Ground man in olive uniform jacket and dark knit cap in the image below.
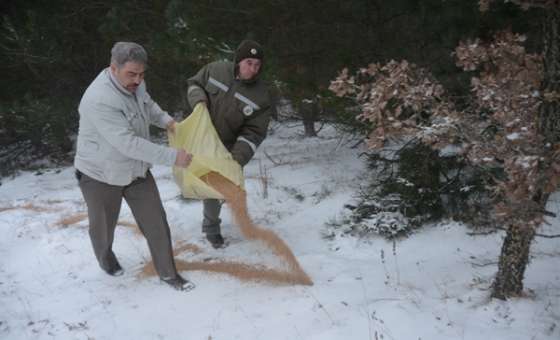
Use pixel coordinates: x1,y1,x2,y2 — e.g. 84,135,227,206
187,40,271,248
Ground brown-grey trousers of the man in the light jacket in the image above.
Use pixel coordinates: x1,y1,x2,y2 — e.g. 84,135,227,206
78,171,177,278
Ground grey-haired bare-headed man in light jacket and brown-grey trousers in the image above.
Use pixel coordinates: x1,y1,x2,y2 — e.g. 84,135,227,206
74,42,194,290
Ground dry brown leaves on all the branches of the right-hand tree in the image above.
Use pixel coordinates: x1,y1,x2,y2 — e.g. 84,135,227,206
330,31,548,226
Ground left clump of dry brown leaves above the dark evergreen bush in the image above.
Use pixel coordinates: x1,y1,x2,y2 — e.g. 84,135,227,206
329,60,453,149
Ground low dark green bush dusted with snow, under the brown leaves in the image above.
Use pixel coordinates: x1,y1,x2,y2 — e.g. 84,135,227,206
352,143,503,237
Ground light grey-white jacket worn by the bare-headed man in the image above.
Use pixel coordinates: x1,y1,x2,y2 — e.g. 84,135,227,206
74,68,177,186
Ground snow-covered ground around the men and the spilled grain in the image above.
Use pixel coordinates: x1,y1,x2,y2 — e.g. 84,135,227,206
0,123,560,340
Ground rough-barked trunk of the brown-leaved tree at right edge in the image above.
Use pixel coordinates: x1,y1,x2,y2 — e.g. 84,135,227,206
492,5,560,299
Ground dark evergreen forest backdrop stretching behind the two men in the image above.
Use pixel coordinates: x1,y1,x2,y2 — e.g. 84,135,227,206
0,0,536,175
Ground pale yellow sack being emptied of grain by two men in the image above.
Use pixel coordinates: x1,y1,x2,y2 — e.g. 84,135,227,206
169,104,244,199
